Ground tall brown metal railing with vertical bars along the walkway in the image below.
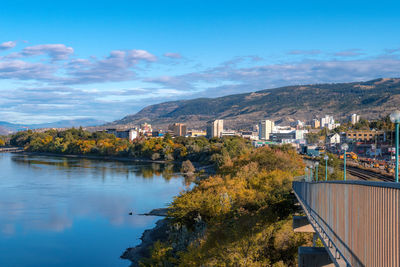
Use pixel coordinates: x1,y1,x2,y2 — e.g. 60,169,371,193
293,181,400,267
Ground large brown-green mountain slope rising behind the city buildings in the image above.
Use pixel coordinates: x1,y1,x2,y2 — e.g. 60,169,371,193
112,78,400,129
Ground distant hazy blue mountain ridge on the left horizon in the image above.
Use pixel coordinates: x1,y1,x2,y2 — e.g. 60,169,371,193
0,118,104,135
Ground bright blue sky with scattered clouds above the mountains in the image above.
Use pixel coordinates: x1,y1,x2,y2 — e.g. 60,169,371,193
0,0,400,124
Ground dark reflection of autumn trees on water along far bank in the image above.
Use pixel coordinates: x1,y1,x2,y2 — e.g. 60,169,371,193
11,155,184,182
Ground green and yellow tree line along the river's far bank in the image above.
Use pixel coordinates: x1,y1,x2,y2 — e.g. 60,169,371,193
9,128,250,164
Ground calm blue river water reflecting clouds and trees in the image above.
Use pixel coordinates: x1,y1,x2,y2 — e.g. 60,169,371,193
0,153,186,267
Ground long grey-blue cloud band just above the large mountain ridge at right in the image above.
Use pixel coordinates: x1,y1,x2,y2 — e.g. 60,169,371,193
146,56,400,96
